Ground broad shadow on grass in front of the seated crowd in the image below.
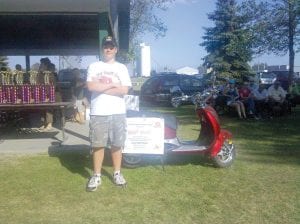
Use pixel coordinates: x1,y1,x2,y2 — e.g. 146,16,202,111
222,107,300,164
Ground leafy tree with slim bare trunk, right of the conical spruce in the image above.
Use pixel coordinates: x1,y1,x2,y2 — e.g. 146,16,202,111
243,0,300,85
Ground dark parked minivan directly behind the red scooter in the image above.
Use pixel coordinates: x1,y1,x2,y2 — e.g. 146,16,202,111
140,73,204,105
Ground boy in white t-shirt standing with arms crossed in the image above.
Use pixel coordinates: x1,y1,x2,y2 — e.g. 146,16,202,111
87,36,131,191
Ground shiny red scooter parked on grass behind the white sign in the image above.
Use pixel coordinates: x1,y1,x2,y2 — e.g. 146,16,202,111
123,89,236,167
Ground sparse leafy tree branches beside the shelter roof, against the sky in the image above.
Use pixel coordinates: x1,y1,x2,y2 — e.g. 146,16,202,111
120,0,174,62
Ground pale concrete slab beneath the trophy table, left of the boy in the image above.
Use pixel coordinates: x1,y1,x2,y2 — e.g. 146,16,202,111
0,121,90,154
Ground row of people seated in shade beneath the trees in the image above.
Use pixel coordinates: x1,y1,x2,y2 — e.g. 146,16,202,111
215,78,300,120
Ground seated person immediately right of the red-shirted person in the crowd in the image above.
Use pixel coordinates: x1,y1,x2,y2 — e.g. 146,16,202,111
253,83,268,118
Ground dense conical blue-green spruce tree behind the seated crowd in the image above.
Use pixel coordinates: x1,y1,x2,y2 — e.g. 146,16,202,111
200,0,252,79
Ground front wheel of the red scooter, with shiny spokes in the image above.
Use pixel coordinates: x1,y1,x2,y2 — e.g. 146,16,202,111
212,141,236,168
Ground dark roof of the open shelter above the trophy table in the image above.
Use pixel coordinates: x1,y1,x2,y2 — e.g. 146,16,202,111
0,0,130,67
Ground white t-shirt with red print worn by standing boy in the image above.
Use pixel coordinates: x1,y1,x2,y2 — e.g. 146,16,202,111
87,61,131,115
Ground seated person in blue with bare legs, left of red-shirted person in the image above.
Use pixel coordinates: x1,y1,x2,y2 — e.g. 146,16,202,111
223,80,247,119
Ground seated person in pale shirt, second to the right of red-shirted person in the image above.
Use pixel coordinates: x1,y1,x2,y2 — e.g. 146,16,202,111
268,80,287,115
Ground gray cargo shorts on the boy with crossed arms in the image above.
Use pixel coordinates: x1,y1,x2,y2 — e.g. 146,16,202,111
89,114,126,148
